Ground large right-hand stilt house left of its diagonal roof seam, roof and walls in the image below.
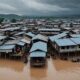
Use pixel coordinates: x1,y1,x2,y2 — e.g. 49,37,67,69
54,38,77,58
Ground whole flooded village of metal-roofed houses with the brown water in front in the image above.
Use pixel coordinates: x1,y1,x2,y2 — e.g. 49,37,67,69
0,18,80,80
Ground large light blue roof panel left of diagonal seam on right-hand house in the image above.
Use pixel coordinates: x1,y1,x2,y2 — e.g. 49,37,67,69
55,38,76,46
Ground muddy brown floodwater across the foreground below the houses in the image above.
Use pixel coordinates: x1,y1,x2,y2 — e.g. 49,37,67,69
0,59,80,80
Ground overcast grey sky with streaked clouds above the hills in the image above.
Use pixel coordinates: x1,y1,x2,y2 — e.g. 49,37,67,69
0,0,80,15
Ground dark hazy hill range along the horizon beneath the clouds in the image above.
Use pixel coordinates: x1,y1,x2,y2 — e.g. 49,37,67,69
0,14,80,19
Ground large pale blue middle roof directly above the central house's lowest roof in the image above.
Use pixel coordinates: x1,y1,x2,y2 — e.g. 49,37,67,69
30,41,47,52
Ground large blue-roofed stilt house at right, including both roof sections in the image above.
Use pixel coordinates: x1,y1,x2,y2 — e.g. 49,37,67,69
54,38,80,59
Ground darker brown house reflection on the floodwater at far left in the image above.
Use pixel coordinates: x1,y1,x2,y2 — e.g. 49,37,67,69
0,59,25,72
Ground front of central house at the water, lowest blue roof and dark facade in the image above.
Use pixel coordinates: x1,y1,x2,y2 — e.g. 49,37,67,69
30,51,46,66
